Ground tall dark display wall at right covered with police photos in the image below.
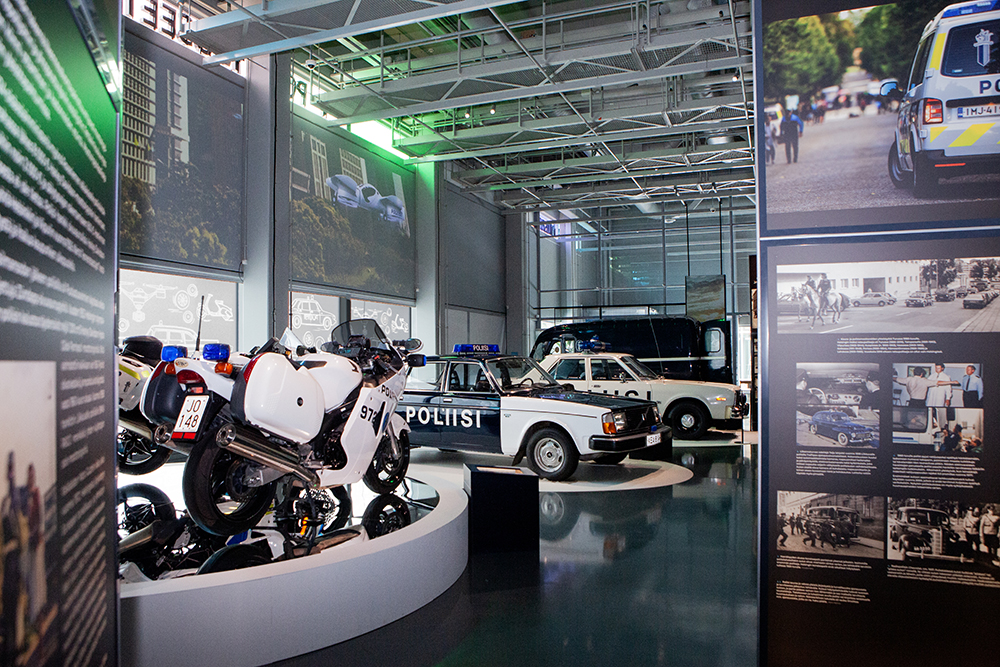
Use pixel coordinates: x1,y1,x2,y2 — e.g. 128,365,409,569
755,0,1000,667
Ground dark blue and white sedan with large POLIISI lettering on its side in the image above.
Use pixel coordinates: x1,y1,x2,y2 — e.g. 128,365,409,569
396,345,670,481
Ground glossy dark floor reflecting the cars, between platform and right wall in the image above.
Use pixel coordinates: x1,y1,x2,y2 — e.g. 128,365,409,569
275,445,757,667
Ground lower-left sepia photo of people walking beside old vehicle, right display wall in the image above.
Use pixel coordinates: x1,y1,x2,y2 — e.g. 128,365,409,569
774,491,885,558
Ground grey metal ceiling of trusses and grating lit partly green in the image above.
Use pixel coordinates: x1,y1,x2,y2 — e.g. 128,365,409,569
180,0,755,213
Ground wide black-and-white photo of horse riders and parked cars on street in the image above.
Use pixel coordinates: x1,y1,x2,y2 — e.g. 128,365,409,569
775,257,1000,334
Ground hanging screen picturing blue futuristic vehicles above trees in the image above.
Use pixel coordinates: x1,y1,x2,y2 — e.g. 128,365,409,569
290,110,416,299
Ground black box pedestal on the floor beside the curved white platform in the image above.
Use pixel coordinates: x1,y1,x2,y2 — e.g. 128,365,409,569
465,464,538,556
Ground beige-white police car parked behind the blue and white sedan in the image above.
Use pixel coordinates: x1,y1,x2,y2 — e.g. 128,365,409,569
541,352,746,440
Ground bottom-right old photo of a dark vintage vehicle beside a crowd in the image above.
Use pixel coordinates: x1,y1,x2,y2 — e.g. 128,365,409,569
887,498,1000,570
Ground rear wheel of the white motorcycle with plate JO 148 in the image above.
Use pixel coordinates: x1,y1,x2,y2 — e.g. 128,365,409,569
182,428,274,535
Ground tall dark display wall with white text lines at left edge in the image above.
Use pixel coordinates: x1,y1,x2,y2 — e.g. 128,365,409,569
0,1,118,665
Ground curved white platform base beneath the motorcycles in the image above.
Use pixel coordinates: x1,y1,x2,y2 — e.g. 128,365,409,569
121,474,468,667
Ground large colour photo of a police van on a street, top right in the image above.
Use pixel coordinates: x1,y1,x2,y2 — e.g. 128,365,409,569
758,0,1000,229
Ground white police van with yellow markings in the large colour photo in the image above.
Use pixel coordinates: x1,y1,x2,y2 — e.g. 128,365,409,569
880,0,1000,196
